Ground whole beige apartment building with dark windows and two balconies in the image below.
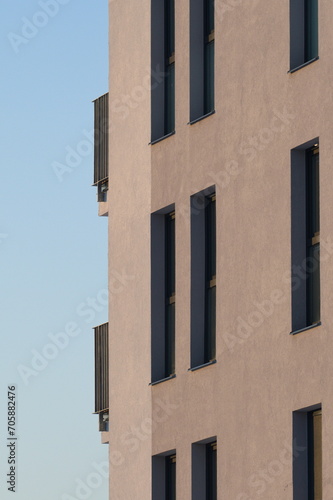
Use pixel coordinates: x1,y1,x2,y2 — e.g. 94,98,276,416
94,0,333,500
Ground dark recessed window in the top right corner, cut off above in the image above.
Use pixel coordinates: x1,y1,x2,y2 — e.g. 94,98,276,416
290,0,319,70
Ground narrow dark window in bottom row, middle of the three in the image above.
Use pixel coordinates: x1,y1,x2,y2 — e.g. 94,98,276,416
192,437,217,500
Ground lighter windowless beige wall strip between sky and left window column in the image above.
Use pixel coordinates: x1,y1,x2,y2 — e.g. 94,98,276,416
108,0,151,500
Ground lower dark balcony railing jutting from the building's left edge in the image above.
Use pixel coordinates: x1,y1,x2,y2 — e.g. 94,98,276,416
94,323,109,431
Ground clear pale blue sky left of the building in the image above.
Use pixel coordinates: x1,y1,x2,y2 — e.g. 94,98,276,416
0,0,108,500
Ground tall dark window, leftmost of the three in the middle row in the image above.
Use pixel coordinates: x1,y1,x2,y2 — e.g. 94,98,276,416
151,206,176,383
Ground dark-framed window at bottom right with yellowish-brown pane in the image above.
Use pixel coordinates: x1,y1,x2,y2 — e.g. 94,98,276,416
293,405,322,500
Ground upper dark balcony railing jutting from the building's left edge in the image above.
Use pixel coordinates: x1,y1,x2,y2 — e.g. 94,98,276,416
94,93,109,201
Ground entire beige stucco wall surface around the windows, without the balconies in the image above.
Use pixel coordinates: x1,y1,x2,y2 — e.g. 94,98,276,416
108,0,333,500
